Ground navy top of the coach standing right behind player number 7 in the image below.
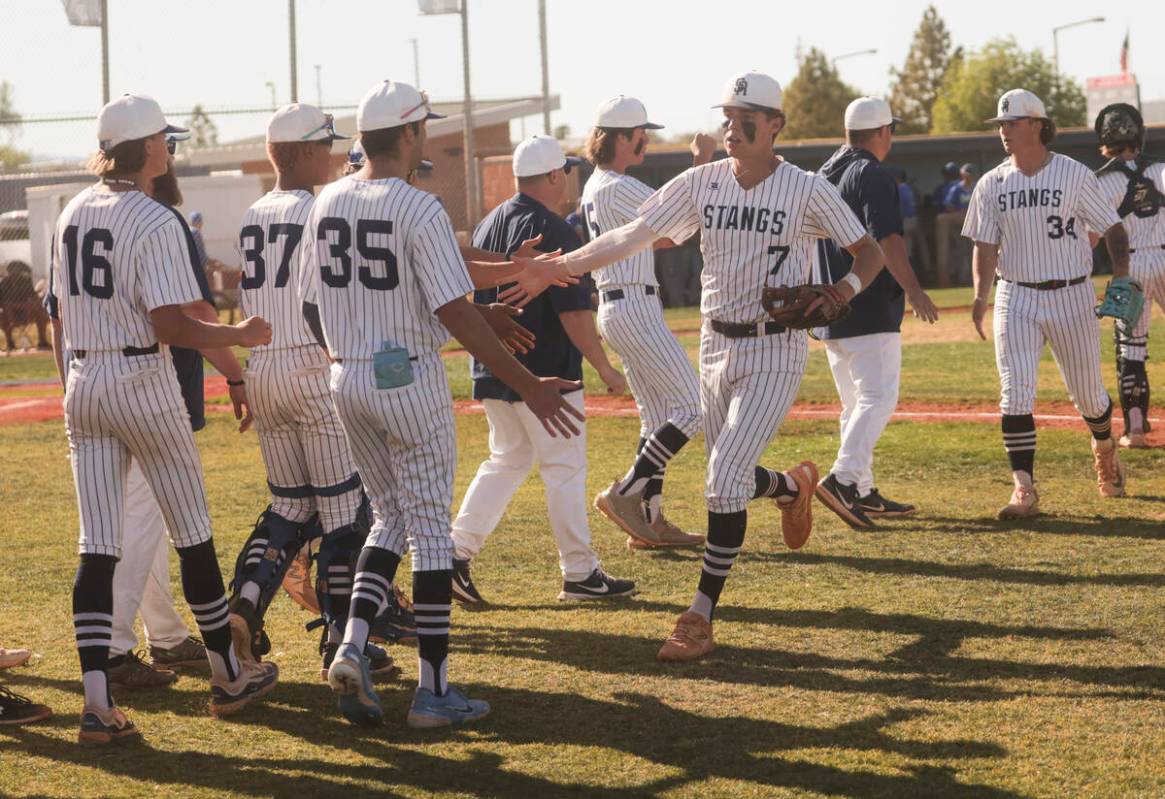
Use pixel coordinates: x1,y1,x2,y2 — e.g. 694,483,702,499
818,144,906,339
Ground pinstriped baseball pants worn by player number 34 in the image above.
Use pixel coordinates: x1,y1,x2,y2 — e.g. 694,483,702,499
991,281,1110,417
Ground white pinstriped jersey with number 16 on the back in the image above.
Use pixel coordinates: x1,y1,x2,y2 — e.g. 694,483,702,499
50,185,203,351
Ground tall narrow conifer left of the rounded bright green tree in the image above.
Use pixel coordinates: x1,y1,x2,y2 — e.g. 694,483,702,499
890,6,962,133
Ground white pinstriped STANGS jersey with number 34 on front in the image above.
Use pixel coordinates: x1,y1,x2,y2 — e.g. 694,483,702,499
962,153,1121,283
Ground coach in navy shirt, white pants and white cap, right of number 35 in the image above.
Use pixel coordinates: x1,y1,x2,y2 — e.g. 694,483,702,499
453,136,635,603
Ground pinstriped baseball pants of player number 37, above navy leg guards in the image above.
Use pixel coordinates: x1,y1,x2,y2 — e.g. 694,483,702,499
247,345,361,532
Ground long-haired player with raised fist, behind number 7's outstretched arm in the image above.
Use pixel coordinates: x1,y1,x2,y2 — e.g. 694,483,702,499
579,94,704,546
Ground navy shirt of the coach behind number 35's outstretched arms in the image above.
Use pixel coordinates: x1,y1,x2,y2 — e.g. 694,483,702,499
469,192,591,402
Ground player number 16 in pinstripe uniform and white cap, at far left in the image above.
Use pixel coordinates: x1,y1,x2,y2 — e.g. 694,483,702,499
50,94,278,745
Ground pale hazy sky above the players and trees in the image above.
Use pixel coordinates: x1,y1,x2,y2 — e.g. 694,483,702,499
0,0,1165,154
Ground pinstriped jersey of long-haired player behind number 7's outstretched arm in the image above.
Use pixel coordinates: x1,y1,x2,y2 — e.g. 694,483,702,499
579,167,659,291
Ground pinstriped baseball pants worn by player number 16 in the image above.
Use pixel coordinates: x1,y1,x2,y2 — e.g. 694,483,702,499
64,347,211,558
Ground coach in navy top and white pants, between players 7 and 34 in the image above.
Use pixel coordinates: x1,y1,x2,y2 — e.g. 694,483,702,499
818,97,938,528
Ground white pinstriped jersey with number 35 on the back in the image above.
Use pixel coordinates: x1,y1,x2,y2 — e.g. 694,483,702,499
302,176,473,359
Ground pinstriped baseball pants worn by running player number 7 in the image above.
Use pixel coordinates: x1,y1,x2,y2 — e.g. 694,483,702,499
700,325,809,514
